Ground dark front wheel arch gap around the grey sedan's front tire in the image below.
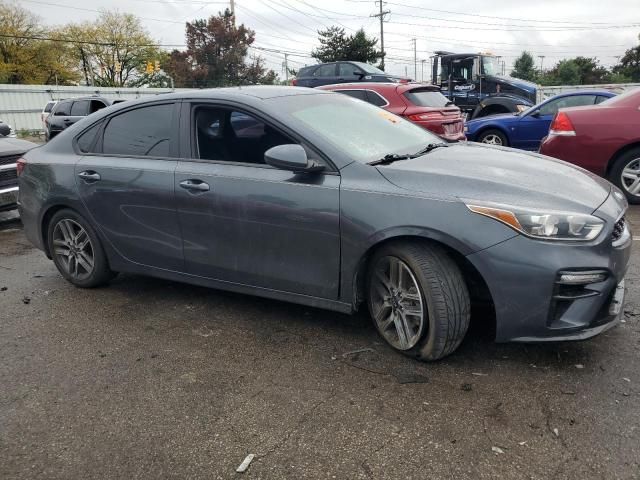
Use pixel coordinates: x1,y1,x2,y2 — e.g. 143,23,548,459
352,233,496,338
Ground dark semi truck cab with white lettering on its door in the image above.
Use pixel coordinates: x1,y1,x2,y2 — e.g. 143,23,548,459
431,52,537,118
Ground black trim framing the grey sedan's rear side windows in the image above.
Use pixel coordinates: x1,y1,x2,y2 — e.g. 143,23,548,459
72,99,182,162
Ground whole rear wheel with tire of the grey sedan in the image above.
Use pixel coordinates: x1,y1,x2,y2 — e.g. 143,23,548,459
47,209,115,288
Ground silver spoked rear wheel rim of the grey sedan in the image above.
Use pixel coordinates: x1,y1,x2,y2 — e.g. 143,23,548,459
53,218,94,280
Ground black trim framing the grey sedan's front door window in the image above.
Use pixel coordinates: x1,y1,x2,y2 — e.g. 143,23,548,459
180,98,339,175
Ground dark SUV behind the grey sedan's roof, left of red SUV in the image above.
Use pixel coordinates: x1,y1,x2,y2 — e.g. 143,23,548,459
292,62,411,87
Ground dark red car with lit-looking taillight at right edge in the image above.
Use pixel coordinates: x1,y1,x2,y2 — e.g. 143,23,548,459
540,88,640,203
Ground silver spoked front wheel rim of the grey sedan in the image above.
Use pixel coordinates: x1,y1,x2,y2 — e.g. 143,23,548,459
370,257,425,350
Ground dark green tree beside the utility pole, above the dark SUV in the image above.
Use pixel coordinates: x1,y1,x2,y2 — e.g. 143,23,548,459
311,26,382,63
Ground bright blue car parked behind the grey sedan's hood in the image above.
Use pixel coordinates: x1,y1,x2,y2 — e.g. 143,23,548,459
464,90,615,151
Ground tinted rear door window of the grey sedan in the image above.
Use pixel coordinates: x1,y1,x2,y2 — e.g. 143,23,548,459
102,103,173,157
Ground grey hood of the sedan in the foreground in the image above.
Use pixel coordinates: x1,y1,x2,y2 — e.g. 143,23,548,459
378,143,611,213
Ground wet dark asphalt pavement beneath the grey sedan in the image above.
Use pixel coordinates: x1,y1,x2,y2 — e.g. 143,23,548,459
0,208,640,480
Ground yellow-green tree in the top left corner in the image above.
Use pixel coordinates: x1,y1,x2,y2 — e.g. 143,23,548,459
0,2,76,84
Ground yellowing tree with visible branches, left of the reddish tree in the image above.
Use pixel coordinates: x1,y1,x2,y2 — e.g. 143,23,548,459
59,12,164,87
